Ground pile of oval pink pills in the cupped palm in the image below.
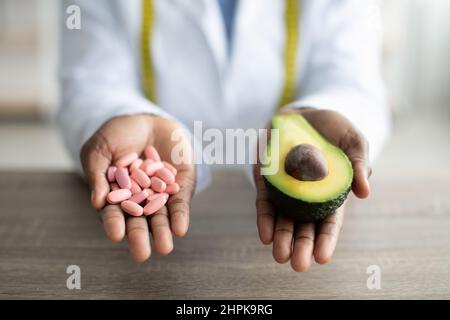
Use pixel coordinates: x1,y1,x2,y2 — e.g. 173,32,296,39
106,146,180,216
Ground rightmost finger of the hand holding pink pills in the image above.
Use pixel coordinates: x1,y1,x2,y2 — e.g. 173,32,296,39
167,165,195,237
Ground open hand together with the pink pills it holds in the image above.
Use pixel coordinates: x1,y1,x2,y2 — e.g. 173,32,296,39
81,115,195,262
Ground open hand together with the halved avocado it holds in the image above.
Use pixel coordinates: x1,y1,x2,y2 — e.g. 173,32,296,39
254,108,371,271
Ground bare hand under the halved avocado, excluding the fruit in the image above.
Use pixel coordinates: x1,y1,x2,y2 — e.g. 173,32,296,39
254,108,371,272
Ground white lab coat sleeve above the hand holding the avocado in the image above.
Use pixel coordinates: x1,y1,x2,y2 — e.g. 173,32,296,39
290,0,389,160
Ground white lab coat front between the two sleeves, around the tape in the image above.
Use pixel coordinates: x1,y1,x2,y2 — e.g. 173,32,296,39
117,0,311,128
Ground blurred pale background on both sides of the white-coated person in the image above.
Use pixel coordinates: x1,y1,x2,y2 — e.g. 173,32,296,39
0,0,450,177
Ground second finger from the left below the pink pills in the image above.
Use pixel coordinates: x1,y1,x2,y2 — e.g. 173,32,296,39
126,216,151,262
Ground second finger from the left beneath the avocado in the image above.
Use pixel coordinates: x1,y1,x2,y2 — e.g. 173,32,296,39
272,216,294,263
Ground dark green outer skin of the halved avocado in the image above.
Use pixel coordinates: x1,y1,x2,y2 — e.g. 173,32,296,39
264,177,351,222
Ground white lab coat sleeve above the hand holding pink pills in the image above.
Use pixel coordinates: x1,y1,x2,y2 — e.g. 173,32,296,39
58,0,208,190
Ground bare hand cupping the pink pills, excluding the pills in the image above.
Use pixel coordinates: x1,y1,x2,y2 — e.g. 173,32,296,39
81,115,196,262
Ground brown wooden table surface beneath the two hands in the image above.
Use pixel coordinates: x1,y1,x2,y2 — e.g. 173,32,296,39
0,172,450,299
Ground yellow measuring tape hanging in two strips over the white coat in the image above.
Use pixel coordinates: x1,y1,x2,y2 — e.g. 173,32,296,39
141,0,300,108
